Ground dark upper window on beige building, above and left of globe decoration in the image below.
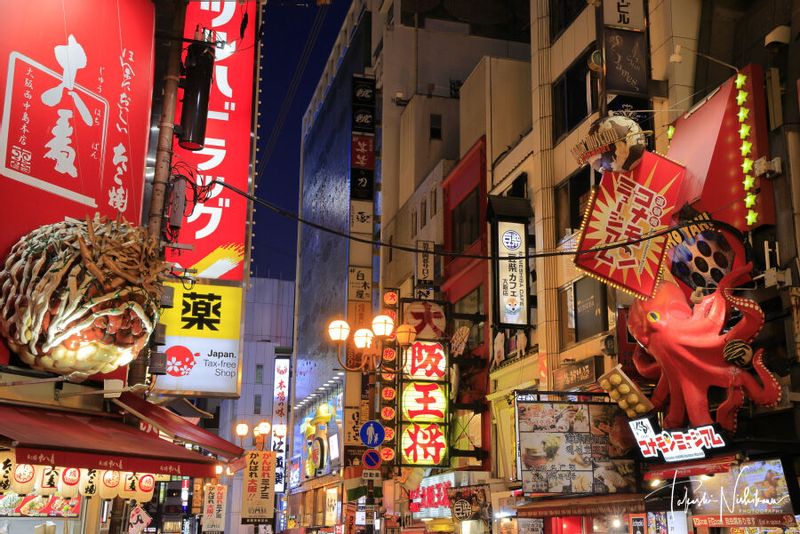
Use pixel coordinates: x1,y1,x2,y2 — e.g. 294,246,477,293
553,48,597,144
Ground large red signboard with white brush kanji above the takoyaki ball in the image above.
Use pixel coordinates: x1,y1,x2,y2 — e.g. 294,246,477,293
0,0,155,276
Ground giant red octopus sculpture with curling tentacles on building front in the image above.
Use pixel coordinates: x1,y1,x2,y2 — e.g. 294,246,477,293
628,264,781,432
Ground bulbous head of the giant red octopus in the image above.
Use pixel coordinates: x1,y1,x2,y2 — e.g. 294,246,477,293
628,282,692,347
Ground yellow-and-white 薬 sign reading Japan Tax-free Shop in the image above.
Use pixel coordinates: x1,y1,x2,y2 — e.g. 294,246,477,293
155,283,241,398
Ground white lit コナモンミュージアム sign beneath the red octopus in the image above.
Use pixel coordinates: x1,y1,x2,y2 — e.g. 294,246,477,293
628,418,725,462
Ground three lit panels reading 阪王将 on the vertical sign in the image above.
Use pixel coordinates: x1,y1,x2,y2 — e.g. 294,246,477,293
398,341,449,466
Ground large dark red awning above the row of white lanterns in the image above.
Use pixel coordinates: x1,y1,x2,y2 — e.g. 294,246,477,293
0,405,216,477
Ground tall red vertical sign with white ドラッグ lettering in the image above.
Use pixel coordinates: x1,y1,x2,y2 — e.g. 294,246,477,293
167,0,258,281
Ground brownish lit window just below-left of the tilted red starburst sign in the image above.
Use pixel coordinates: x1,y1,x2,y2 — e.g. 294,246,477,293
558,276,608,349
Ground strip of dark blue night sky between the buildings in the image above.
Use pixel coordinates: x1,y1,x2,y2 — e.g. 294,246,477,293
252,0,350,280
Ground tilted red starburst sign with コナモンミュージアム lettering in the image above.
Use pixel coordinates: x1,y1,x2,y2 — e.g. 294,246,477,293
575,152,685,298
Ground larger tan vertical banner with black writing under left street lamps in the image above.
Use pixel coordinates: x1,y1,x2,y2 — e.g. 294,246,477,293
242,450,275,525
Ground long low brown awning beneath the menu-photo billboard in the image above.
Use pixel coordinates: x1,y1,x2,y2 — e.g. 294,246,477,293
517,493,645,517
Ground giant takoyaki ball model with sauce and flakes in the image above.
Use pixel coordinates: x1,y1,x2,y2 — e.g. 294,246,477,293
0,216,165,375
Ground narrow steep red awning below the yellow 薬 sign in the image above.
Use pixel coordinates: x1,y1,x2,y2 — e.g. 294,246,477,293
114,393,244,459
